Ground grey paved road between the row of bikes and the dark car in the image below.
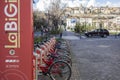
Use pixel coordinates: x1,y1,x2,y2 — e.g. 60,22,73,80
63,32,120,80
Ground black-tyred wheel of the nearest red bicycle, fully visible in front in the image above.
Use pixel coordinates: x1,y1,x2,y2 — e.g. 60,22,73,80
49,61,71,80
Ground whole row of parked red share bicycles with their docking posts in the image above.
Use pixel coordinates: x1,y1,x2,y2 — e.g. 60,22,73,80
33,37,72,80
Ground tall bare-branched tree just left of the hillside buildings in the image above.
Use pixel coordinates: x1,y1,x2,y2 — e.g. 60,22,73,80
46,0,66,30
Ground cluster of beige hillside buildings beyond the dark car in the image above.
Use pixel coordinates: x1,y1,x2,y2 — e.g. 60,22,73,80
64,5,120,30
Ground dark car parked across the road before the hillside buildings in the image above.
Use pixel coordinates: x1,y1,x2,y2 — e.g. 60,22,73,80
85,29,109,37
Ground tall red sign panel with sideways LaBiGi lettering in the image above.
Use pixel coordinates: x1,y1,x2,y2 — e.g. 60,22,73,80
0,0,33,80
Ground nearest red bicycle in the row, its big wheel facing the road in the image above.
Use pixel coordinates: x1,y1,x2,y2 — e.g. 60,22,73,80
37,49,72,80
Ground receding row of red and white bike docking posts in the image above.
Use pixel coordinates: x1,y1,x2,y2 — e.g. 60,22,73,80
33,37,56,80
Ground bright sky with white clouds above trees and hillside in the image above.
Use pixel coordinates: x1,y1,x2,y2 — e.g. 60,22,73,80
33,0,120,11
